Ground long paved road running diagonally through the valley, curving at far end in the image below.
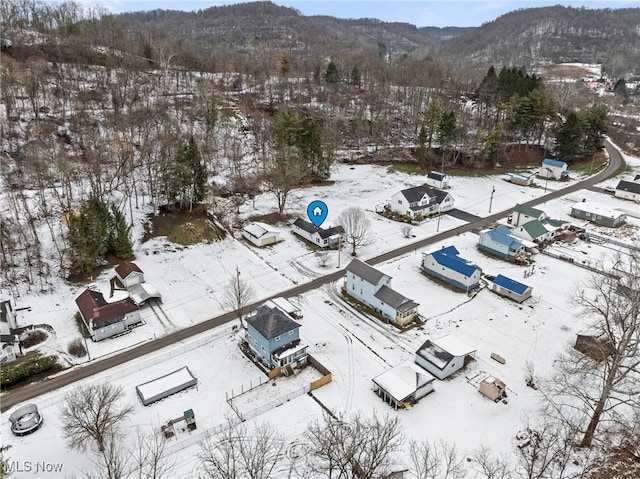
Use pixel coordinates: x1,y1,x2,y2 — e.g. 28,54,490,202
0,140,624,412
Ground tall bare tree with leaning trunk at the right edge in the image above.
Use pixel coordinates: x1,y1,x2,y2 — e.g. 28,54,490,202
545,249,640,447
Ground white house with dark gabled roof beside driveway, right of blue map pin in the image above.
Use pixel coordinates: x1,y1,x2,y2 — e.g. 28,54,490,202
389,185,453,219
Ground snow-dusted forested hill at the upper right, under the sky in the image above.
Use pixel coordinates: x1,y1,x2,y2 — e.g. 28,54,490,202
439,5,640,77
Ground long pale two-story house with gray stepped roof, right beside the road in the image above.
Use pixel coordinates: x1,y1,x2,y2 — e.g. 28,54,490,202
345,259,418,327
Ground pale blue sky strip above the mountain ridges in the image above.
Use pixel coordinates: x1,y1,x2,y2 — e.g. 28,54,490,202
75,0,640,27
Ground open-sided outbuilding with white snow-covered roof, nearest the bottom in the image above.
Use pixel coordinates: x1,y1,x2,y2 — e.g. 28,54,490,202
372,361,435,409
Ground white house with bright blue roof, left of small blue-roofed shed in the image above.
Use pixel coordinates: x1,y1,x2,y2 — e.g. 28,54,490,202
422,246,482,291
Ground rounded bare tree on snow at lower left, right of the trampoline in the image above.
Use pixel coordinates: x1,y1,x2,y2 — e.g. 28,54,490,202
60,383,133,451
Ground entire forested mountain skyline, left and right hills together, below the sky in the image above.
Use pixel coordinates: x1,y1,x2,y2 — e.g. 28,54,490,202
119,2,640,76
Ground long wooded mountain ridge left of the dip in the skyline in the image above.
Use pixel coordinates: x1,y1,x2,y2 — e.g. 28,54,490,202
120,2,467,58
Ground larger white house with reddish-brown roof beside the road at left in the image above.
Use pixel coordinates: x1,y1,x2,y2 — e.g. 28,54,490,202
76,289,142,341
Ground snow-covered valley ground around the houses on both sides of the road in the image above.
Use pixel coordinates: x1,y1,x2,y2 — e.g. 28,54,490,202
0,143,640,478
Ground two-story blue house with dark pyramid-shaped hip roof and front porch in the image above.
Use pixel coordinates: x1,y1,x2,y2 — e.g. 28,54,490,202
246,306,307,369
